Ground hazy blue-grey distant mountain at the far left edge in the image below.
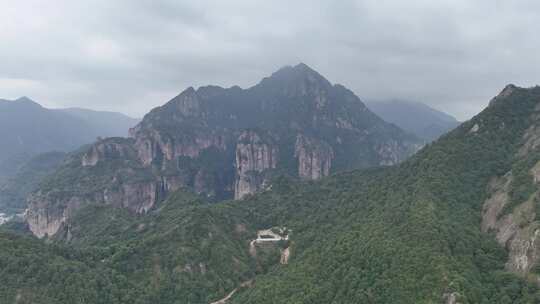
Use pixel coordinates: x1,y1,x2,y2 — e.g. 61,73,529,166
0,97,138,180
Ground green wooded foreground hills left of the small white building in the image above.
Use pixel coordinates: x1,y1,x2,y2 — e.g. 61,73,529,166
0,191,279,304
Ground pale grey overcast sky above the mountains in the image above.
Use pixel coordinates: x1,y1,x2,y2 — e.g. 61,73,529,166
0,0,540,119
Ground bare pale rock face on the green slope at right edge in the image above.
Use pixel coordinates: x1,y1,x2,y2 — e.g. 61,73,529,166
482,98,540,283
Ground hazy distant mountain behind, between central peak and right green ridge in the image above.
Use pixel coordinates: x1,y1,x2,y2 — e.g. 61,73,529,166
367,100,459,142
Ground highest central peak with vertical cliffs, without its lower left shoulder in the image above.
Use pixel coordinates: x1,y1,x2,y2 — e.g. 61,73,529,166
131,64,417,198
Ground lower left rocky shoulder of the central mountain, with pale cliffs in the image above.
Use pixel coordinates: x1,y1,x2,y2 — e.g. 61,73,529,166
26,138,175,237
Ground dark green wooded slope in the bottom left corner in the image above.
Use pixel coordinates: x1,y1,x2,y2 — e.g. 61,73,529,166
0,231,140,304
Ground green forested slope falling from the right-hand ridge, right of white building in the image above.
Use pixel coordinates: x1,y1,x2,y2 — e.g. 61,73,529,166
233,86,540,303
